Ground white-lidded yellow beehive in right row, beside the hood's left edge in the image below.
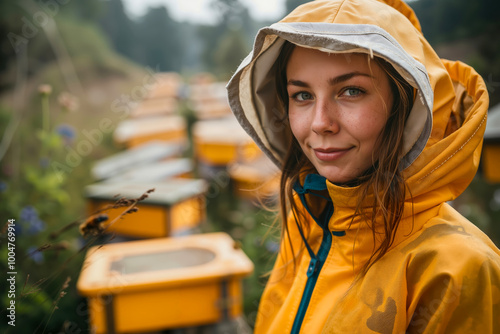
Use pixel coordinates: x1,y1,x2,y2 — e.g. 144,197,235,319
193,117,262,166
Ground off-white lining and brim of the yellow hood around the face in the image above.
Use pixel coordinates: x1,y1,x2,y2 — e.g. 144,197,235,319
227,23,433,168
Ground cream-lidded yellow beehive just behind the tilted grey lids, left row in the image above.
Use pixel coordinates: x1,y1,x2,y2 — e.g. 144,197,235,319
114,115,187,148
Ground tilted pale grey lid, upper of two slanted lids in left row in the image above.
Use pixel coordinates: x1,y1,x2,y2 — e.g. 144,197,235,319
92,141,184,180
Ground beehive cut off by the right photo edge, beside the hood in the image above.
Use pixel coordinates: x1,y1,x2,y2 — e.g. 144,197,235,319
481,105,500,183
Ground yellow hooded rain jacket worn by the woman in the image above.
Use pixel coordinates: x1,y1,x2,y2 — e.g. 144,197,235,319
227,0,500,334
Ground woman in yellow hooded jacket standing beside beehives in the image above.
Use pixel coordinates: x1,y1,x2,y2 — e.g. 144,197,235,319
228,0,500,333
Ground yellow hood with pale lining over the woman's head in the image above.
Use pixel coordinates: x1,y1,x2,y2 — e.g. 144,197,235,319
227,0,488,202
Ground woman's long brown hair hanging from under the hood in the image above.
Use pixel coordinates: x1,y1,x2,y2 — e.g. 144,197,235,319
275,41,414,275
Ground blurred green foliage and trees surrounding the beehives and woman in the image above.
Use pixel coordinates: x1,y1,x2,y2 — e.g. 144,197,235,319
0,0,500,333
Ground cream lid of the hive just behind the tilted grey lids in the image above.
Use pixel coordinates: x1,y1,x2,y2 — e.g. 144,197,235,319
114,115,186,142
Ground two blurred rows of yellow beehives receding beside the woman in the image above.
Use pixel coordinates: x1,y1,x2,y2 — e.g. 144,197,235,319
74,74,284,333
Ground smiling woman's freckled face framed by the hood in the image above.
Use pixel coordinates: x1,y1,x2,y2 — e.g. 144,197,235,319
286,46,393,184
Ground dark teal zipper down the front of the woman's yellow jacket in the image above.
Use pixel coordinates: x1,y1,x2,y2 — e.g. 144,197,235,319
291,228,332,334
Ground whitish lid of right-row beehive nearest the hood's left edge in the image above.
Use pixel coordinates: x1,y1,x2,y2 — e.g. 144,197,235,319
193,116,252,144
